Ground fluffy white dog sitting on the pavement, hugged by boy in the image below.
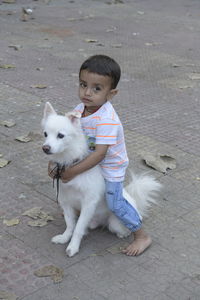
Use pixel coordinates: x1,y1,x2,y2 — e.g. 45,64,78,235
42,102,161,257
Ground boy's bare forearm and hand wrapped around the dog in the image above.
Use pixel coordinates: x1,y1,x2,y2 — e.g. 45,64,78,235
61,144,109,182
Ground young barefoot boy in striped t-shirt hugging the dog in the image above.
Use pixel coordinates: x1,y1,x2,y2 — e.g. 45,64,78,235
49,55,151,256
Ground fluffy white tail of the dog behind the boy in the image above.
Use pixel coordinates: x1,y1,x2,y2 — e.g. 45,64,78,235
124,172,162,217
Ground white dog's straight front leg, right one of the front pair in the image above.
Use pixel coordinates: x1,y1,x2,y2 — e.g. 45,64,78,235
66,205,96,257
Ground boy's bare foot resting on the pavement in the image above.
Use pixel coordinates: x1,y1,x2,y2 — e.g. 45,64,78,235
122,229,152,256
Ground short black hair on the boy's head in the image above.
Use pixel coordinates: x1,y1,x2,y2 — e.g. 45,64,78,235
79,54,121,89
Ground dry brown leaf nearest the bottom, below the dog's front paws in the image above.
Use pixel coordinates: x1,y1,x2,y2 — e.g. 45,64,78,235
34,265,64,283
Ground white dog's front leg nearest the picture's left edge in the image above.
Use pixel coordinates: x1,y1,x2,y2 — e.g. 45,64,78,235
51,206,76,244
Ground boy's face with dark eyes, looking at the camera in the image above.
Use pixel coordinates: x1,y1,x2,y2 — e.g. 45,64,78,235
79,70,117,109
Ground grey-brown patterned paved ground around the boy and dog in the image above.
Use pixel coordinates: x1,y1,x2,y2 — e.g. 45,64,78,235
0,0,200,300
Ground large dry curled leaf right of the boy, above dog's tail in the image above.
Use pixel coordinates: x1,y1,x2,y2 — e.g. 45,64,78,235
142,153,176,173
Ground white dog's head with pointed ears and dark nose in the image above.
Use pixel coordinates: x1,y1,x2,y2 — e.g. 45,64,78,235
42,102,81,154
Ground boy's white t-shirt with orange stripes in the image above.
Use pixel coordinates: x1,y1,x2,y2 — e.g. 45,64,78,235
74,101,128,181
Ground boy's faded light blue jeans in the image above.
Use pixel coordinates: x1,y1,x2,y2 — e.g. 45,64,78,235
105,180,142,232
